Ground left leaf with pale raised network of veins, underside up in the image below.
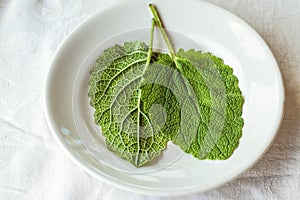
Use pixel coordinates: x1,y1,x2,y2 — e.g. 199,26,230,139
88,42,177,166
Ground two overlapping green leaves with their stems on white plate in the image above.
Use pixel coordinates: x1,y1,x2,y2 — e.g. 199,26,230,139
89,5,244,167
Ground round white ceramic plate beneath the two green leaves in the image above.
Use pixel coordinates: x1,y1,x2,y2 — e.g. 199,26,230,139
45,0,284,196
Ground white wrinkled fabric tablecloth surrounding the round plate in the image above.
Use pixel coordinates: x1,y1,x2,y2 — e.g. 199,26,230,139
0,0,300,200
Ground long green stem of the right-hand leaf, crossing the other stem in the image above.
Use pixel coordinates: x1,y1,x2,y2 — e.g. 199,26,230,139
149,4,175,61
